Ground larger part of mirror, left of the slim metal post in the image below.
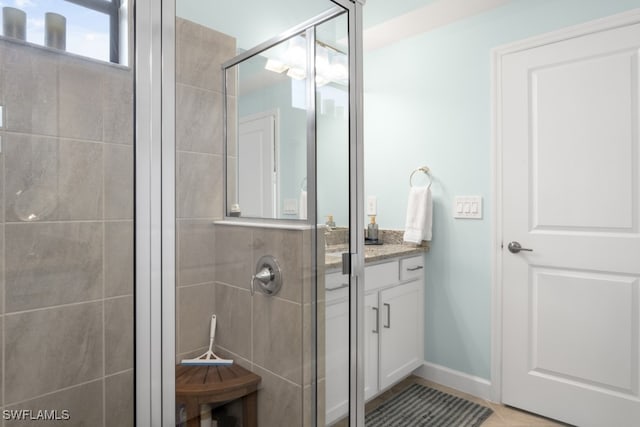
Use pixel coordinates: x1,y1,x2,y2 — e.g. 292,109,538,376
226,35,307,219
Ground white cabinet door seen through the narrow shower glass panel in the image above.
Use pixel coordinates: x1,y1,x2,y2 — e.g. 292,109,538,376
325,300,349,424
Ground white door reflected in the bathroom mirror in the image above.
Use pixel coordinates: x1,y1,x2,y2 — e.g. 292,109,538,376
238,111,278,218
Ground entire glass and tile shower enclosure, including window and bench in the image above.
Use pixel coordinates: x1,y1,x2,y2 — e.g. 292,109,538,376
0,0,363,426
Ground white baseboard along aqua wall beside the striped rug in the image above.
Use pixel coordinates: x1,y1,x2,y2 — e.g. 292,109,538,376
413,362,493,400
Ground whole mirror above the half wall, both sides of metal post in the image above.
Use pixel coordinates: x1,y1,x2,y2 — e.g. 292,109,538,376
225,11,348,221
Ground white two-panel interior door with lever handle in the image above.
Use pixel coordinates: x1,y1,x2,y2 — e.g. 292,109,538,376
498,17,640,427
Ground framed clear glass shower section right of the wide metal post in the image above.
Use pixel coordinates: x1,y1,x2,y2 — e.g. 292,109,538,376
168,0,364,426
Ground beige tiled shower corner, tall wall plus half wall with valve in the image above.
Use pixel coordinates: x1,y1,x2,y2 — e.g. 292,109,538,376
176,18,324,427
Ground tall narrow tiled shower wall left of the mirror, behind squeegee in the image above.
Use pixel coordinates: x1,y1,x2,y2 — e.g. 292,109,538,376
176,18,235,360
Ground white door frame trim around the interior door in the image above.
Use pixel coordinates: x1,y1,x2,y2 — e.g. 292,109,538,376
491,9,640,406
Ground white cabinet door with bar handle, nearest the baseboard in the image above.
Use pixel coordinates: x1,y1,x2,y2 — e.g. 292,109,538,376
380,280,424,390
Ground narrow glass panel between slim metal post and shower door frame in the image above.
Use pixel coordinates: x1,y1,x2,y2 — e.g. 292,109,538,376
315,13,352,425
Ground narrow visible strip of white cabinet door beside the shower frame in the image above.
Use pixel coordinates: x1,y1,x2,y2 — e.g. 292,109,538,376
364,292,380,400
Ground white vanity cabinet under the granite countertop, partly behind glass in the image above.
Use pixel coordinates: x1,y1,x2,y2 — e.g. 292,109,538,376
325,254,424,424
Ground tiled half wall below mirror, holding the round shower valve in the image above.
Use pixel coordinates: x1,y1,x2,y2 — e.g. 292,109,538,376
214,224,324,427
